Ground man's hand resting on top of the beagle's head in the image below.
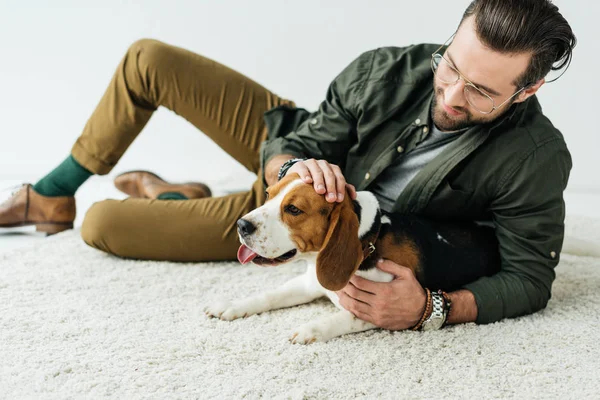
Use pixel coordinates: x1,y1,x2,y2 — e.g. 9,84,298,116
288,158,356,203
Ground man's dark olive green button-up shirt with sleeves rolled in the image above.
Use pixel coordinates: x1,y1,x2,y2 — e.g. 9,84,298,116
261,44,571,323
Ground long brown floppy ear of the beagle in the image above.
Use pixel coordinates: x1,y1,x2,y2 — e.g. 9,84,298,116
317,195,363,291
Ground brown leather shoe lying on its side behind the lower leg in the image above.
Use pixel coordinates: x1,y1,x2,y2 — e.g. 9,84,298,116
115,171,212,199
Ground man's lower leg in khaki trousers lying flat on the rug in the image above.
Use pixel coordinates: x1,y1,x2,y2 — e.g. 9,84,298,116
81,178,265,262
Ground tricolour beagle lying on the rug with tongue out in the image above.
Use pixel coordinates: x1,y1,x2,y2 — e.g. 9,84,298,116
205,174,500,344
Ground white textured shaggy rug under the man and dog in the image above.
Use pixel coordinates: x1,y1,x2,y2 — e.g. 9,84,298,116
0,219,600,399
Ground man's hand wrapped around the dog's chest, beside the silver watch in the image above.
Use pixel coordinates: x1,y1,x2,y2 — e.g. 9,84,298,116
336,260,427,330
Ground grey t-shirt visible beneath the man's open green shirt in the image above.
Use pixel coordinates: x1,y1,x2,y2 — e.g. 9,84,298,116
369,124,466,212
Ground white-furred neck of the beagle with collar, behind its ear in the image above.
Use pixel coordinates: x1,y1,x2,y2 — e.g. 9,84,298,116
353,192,381,263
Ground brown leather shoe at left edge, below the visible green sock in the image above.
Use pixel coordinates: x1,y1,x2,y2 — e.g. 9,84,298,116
0,184,75,235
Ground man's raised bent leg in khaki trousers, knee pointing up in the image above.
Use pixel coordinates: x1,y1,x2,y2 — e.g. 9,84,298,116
72,39,293,175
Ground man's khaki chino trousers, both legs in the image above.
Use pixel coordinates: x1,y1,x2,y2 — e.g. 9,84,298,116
72,39,294,261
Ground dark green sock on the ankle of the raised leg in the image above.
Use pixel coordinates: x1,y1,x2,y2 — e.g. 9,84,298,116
33,155,94,197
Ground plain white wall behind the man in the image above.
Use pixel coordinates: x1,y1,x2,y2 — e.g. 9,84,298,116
0,0,600,192
